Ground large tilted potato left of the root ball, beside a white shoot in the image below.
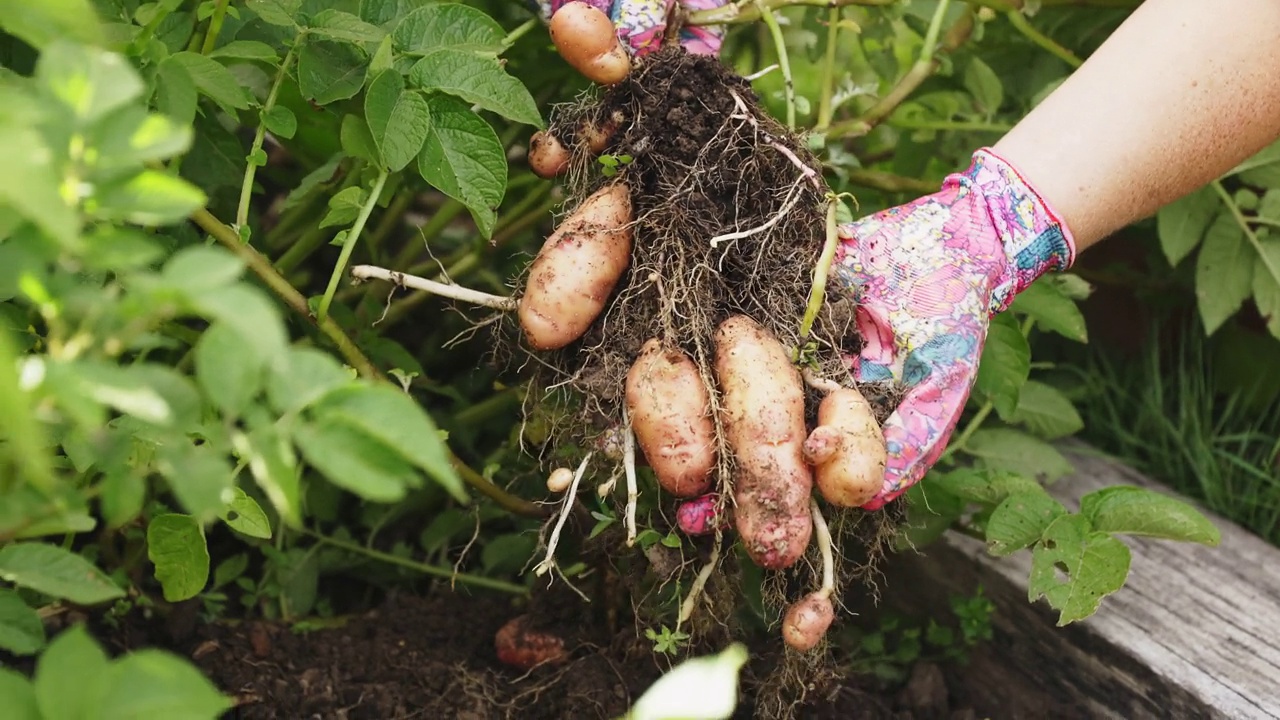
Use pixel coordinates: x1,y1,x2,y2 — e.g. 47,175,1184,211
518,183,631,350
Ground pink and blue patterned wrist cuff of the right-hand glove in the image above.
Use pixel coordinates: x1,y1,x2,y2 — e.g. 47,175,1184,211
947,147,1075,315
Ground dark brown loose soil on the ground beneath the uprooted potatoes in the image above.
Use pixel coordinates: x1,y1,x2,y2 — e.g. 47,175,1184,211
40,579,974,720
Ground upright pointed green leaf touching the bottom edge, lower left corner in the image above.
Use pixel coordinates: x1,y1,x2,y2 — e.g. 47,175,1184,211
35,624,110,719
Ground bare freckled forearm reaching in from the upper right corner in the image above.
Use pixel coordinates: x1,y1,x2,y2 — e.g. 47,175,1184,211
995,0,1280,250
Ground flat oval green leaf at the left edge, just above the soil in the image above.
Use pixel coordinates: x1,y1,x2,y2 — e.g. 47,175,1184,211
0,542,124,605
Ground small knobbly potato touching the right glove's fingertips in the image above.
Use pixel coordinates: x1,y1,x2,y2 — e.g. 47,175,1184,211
804,388,887,507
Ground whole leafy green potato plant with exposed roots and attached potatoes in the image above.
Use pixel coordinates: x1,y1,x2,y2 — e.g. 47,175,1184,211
0,0,1249,717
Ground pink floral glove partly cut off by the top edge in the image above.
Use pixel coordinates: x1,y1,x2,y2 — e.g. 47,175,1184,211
531,0,727,56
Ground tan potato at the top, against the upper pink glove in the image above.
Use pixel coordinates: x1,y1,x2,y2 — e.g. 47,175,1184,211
548,0,631,85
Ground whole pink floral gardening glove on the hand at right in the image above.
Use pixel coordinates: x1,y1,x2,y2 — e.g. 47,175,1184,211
832,149,1075,510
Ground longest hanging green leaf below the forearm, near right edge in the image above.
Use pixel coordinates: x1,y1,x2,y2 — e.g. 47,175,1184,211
1196,213,1254,336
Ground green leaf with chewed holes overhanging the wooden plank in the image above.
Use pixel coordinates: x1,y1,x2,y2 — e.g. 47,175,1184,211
1027,515,1130,626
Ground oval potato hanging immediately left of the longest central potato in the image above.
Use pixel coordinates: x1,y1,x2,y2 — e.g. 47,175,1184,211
626,338,716,497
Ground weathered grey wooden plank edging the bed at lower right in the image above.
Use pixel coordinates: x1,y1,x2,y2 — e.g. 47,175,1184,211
883,443,1280,720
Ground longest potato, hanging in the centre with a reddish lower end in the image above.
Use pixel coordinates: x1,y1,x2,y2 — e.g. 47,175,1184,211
716,315,813,570
